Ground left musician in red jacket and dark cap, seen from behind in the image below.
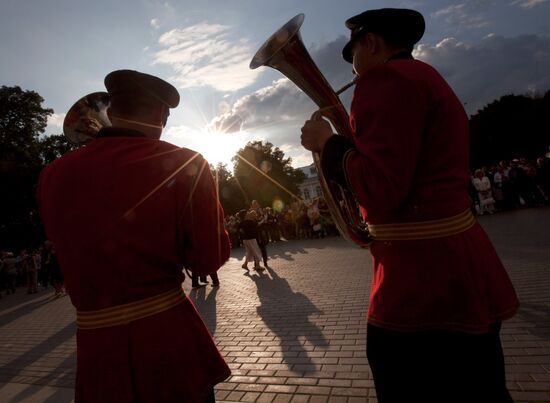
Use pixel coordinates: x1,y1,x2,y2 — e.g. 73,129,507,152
38,70,230,403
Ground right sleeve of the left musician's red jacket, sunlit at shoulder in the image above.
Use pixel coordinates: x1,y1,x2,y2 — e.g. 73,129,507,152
179,155,230,275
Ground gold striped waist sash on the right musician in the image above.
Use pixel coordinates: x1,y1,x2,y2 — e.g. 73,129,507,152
368,209,476,241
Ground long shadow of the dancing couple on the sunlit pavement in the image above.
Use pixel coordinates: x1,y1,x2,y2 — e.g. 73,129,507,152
245,268,328,372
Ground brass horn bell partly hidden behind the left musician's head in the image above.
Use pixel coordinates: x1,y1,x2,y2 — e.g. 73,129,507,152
63,92,111,146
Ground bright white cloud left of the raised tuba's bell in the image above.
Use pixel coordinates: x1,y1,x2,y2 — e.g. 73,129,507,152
154,23,258,91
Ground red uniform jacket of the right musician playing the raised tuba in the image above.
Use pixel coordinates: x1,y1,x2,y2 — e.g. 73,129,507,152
321,55,518,333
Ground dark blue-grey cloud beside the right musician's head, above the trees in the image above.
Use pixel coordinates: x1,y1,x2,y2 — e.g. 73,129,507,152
415,35,550,114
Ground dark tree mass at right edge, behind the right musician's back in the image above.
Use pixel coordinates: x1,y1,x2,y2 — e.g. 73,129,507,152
470,91,550,168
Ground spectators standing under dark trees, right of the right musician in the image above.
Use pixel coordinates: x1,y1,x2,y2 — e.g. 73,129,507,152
470,157,550,215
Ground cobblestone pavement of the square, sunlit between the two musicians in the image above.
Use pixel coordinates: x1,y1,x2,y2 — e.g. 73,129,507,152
0,208,550,403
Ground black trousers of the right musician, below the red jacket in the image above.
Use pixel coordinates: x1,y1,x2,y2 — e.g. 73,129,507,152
367,322,513,403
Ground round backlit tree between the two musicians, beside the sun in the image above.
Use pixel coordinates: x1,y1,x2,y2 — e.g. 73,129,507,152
232,141,305,211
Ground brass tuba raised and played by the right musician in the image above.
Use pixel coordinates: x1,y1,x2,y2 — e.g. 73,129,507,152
250,14,372,248
